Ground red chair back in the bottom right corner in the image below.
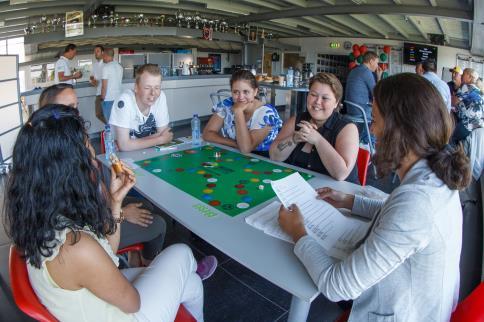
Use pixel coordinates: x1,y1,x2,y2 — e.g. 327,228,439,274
450,282,484,322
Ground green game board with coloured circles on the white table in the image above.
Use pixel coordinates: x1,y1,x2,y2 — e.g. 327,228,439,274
136,145,312,217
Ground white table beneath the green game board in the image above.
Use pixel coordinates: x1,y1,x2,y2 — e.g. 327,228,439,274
98,144,384,322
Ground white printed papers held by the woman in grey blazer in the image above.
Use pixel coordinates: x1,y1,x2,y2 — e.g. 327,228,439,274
246,172,369,259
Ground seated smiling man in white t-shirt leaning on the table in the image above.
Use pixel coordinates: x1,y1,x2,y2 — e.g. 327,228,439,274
109,64,173,151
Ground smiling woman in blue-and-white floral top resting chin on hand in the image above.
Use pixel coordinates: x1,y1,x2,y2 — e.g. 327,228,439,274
203,70,282,156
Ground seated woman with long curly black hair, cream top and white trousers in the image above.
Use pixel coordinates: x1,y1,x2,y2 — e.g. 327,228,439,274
5,105,207,321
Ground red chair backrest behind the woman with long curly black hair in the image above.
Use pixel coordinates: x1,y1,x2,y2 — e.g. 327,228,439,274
9,245,57,322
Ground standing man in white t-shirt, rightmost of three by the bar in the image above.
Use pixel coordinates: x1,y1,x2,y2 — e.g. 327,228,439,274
101,48,123,120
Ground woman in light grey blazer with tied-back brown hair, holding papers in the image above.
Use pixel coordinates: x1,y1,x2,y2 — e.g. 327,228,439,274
279,73,470,321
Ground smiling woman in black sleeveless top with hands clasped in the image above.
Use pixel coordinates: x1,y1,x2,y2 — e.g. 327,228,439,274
269,73,358,183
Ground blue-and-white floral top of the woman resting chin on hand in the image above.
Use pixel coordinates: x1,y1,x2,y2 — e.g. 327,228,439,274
212,98,282,151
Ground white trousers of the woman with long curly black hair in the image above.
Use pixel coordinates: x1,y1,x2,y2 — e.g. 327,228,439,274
121,244,203,322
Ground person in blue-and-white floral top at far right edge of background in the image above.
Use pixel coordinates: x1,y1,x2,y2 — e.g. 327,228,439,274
452,68,484,142
